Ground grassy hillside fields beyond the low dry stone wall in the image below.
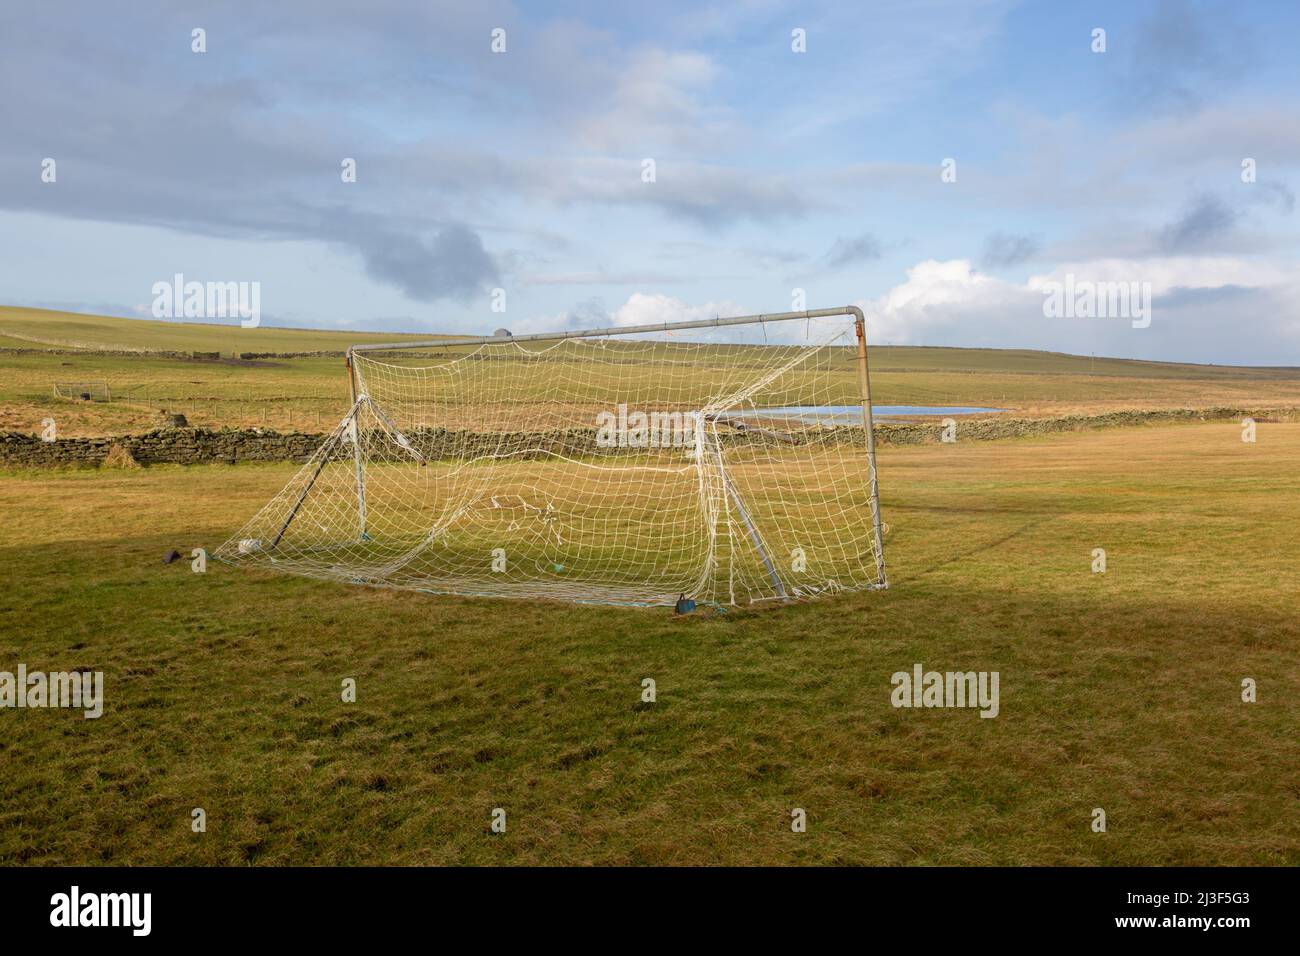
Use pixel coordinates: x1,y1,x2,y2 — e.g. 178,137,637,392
0,307,1300,437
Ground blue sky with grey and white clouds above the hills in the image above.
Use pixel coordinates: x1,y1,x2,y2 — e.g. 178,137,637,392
0,0,1300,365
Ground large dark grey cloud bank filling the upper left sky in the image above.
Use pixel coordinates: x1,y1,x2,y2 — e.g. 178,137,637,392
0,3,498,302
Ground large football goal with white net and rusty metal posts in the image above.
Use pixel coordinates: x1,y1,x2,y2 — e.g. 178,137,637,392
216,306,888,605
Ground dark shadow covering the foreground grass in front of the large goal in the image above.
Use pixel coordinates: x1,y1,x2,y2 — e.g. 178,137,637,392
0,535,1300,864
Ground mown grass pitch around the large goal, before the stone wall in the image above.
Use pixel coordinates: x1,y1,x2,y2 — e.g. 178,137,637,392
0,421,1300,865
